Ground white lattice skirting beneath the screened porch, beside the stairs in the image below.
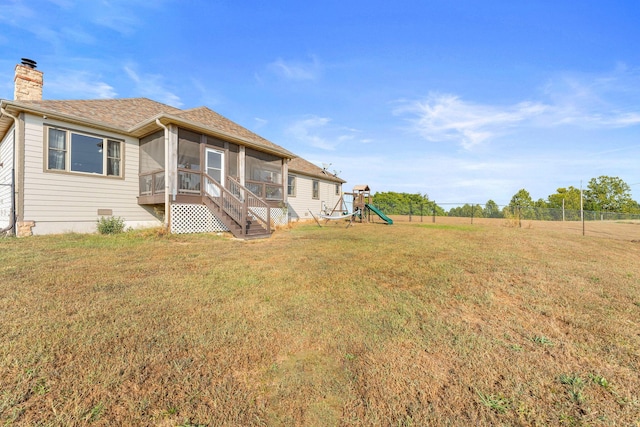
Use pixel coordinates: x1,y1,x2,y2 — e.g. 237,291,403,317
171,203,288,234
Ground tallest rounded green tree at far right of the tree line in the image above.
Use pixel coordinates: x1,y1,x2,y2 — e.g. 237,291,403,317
584,175,637,212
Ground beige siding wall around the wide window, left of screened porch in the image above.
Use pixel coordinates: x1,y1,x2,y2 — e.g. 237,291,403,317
24,115,161,234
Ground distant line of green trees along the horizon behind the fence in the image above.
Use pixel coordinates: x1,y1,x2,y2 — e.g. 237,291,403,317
373,175,640,220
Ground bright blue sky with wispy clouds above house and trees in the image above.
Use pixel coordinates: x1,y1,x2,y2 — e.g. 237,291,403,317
0,0,640,205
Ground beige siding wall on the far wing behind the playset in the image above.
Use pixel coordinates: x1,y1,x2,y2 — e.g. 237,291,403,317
287,172,342,221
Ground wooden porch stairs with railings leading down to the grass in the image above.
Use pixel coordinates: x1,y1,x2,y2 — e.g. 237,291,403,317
202,174,272,240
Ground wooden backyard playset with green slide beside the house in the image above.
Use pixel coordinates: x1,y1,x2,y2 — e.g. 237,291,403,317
309,184,393,228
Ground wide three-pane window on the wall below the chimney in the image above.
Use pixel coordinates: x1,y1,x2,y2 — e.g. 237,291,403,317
46,127,122,176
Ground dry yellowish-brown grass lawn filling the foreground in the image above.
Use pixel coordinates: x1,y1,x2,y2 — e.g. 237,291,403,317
0,219,640,426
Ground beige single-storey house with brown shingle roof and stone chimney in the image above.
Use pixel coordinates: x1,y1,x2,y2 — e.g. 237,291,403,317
0,59,345,238
